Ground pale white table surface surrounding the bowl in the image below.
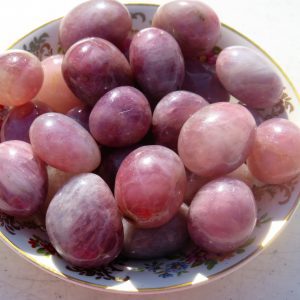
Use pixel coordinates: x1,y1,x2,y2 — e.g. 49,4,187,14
0,0,300,300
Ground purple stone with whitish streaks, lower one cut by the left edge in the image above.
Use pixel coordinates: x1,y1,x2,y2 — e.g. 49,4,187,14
0,141,47,217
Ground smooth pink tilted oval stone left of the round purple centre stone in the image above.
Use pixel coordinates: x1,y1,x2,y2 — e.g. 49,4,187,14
29,113,101,173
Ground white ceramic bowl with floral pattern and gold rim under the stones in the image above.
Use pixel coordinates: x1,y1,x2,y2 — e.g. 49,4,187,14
0,4,300,293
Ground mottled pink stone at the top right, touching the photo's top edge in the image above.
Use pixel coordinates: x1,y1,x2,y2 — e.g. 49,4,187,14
152,0,221,59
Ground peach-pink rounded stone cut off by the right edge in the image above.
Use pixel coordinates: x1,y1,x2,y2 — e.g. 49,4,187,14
247,118,300,184
